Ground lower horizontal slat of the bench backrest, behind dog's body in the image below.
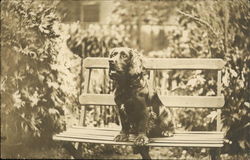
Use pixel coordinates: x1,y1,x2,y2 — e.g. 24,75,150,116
79,94,224,108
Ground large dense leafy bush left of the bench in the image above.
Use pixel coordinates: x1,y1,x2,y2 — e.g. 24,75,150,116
1,0,65,150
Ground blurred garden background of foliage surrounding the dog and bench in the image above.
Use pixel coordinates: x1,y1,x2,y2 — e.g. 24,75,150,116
1,0,250,159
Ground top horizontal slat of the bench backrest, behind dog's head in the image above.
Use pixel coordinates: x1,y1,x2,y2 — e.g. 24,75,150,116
84,57,225,70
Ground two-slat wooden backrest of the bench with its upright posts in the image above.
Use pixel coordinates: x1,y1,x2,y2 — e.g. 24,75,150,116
79,57,225,131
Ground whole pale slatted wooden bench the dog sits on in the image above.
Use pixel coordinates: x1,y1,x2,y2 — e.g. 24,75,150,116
53,58,225,159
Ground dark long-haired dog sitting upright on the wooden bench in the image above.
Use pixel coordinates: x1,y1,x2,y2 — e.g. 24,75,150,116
109,47,173,158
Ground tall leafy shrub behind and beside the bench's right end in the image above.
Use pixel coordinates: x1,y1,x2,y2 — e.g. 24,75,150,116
155,1,250,153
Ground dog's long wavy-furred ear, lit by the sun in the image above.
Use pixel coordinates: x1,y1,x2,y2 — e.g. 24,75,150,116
128,49,143,76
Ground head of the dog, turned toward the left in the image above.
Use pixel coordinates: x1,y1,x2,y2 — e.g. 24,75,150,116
109,47,143,79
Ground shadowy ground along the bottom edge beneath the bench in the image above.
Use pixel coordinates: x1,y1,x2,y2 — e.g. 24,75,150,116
1,145,250,160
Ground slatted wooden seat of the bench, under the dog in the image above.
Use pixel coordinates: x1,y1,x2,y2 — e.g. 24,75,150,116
53,126,224,147
